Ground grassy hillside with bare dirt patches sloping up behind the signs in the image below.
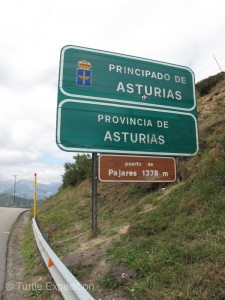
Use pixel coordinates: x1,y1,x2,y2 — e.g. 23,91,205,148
24,73,225,300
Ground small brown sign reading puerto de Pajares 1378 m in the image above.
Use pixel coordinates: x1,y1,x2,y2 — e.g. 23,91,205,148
98,155,176,182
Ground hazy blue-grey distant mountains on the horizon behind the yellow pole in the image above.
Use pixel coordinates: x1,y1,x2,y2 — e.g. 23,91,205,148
0,180,61,200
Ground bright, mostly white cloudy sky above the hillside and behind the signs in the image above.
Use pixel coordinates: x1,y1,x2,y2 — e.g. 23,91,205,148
0,0,225,183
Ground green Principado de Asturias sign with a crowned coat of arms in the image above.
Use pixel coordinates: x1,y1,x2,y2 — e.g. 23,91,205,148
58,46,196,115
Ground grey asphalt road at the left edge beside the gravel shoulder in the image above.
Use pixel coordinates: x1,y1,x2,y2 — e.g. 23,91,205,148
0,207,26,299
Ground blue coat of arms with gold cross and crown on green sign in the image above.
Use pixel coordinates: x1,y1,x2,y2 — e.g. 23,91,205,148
76,60,92,87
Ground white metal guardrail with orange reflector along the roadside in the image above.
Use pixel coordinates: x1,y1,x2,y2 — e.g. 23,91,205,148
32,218,94,300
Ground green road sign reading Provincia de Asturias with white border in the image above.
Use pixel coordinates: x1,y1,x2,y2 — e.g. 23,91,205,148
57,99,198,156
